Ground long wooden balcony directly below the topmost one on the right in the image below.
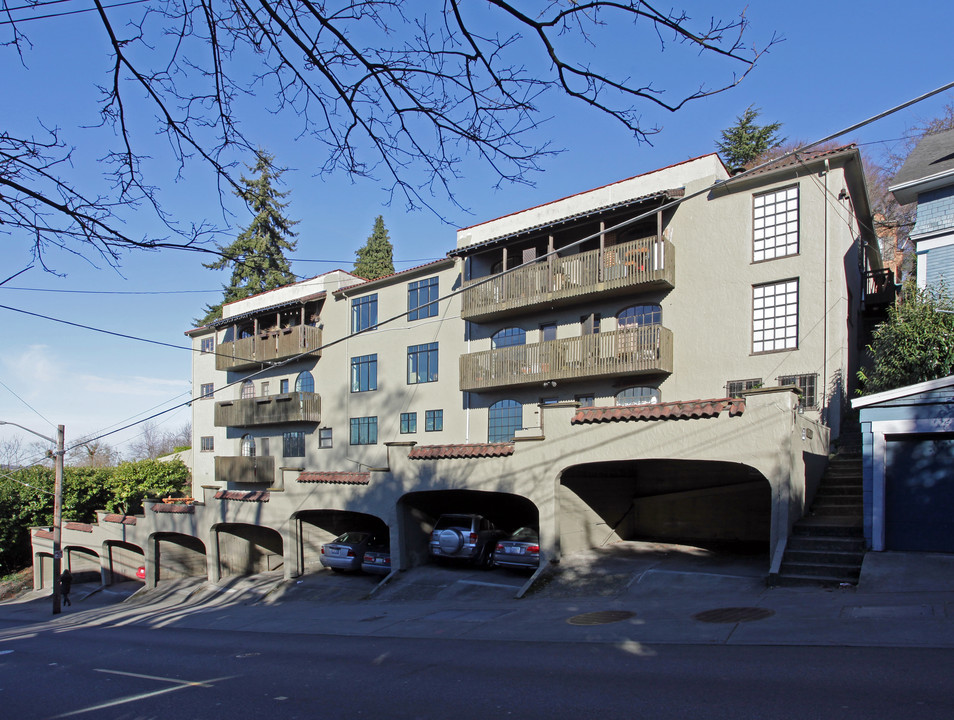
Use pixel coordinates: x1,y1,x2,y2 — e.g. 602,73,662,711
460,325,672,392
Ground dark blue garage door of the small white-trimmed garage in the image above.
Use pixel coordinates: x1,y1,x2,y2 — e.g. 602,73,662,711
885,434,954,552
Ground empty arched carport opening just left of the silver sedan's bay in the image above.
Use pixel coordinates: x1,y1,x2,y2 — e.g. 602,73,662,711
209,523,285,582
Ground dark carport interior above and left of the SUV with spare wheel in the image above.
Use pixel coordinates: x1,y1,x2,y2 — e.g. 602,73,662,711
391,490,540,570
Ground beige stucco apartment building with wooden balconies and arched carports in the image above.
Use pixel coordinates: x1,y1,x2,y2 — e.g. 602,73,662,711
33,147,881,584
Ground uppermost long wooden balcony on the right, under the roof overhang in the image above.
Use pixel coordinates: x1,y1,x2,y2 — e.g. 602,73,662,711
461,237,676,322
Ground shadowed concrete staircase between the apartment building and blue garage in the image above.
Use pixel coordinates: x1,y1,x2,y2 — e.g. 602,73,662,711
772,436,865,585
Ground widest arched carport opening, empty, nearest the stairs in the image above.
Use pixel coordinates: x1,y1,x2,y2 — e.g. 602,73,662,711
560,458,772,553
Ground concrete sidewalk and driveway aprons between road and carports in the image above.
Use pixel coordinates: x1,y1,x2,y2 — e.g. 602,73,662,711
0,551,954,651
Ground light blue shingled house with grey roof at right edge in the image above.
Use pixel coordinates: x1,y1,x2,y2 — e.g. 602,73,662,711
888,130,954,290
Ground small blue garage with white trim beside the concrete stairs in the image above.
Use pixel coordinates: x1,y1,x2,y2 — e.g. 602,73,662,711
851,376,954,552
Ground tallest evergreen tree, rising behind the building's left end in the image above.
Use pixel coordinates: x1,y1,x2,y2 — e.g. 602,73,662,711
196,150,298,325
